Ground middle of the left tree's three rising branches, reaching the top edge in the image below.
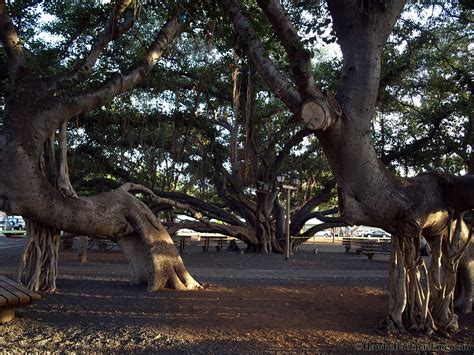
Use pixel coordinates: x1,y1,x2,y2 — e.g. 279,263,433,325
48,0,135,91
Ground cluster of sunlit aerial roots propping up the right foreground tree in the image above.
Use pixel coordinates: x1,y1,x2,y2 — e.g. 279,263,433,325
385,215,470,335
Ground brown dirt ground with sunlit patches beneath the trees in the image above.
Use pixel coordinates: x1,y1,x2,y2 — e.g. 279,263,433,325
0,238,474,354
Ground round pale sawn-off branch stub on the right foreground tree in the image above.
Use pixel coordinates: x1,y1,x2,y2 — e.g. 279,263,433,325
300,95,342,131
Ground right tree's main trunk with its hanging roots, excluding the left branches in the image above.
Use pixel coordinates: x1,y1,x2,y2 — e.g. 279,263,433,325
324,1,474,333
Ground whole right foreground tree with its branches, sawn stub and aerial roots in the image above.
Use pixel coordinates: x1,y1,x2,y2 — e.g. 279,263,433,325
221,0,474,332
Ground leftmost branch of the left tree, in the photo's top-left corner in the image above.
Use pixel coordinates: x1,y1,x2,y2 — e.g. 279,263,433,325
0,0,25,82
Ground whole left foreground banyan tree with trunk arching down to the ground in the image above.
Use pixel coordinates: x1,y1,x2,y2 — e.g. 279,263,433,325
0,0,200,291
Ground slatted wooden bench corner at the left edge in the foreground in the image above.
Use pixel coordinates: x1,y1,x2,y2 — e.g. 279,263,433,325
0,276,41,323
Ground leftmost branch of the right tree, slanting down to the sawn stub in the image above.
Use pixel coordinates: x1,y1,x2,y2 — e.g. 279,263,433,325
220,0,302,113
